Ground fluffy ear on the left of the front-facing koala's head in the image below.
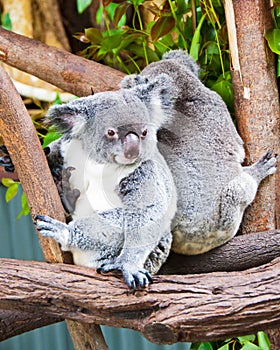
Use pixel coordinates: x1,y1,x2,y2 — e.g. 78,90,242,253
46,100,86,135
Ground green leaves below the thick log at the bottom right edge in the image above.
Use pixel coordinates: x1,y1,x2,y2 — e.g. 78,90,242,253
191,332,270,350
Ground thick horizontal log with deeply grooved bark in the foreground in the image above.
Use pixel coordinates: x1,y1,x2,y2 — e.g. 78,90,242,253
0,259,280,344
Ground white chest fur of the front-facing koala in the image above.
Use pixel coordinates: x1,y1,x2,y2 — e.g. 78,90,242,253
62,140,136,218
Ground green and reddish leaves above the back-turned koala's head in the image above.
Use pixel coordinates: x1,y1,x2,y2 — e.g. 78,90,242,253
75,0,233,112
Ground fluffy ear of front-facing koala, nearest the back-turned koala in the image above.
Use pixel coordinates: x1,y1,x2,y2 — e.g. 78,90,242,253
133,73,178,128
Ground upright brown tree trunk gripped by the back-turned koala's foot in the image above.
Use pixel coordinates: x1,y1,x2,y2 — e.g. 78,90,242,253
232,0,280,233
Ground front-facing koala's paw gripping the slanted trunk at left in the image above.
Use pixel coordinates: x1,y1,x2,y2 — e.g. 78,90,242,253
35,215,70,250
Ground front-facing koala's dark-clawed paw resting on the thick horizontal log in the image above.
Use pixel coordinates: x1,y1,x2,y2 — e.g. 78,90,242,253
97,261,153,290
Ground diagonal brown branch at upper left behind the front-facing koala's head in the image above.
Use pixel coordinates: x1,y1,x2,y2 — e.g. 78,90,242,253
0,27,124,96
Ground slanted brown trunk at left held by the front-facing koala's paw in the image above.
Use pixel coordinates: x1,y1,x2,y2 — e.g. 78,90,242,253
0,67,107,350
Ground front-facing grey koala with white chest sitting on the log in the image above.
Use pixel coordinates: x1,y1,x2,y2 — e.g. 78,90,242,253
36,74,177,289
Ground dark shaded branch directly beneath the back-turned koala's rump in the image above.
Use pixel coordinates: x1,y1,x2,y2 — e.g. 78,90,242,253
159,230,280,275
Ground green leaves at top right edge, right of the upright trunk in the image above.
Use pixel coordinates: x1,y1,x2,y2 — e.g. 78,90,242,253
265,1,280,78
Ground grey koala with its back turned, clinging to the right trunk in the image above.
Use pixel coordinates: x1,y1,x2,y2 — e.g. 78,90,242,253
122,50,277,255
